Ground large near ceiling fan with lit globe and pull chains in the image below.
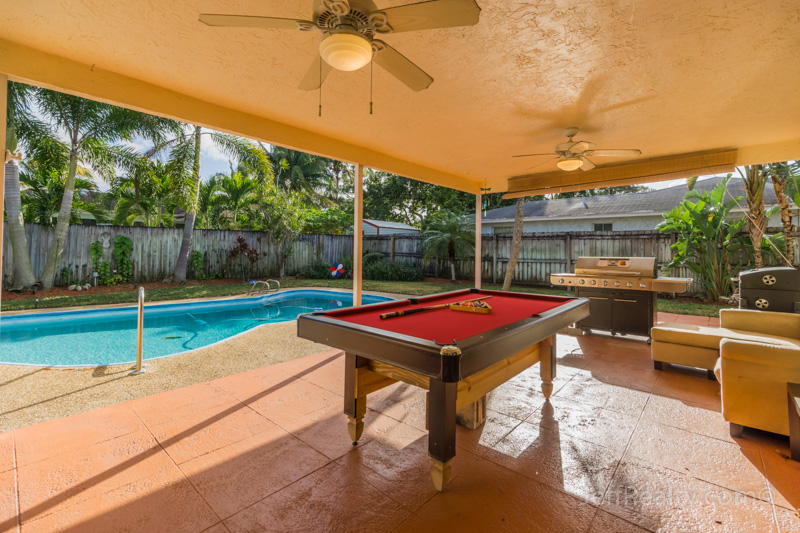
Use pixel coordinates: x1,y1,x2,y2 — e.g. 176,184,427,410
200,0,481,91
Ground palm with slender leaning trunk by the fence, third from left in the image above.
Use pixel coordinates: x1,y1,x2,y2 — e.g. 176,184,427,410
152,126,273,283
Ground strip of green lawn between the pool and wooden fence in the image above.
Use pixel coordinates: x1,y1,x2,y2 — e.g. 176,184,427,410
2,279,720,317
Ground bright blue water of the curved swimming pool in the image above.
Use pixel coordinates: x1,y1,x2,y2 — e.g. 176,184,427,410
0,290,390,366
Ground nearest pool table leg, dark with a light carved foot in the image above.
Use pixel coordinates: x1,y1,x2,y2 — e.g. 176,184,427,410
428,379,458,492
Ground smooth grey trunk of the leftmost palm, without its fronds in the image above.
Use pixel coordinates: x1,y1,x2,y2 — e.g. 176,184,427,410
0,156,36,290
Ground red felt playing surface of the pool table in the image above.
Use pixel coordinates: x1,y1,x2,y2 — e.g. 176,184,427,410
325,290,573,343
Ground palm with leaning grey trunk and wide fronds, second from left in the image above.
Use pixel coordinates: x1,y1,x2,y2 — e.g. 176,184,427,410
34,88,176,289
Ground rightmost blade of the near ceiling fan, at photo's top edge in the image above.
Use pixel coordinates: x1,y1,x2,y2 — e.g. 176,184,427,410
381,0,481,33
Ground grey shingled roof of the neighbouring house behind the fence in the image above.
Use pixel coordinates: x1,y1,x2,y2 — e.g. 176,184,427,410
483,177,778,224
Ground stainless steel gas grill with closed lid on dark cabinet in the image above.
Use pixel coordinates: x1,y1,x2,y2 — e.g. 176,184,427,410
550,257,692,342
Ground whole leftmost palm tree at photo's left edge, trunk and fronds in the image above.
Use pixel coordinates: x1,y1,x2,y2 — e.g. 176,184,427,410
4,82,36,290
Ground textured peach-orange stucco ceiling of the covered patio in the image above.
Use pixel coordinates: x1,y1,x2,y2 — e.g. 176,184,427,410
0,0,800,193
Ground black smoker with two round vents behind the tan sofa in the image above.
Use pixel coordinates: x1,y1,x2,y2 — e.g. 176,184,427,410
739,267,800,313
